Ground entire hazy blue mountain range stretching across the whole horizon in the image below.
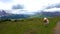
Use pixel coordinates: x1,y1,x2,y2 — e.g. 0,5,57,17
0,10,60,19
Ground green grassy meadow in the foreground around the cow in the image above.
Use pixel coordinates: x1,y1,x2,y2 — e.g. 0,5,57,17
0,17,60,34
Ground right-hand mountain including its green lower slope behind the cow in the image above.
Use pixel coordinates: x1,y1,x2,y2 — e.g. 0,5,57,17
31,11,60,18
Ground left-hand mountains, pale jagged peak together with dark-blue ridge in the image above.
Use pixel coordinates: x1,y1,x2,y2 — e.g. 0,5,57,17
0,10,29,19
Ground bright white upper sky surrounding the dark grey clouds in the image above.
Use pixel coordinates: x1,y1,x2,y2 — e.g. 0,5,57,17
0,0,60,11
